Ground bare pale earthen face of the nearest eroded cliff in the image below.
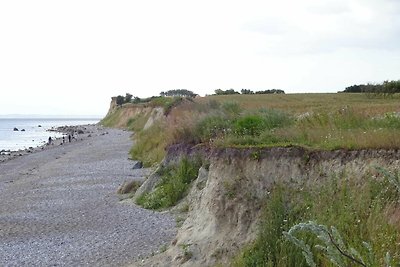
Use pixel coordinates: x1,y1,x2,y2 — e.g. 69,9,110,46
137,148,400,266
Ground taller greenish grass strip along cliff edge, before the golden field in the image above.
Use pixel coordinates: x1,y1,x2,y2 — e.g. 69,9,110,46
174,100,400,149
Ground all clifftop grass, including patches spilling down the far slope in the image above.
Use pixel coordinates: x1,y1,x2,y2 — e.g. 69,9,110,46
102,93,400,166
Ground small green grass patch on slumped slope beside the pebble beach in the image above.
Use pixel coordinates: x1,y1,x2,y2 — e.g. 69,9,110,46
136,158,201,210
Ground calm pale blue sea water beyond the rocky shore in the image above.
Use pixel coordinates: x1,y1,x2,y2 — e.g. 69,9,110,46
0,118,99,151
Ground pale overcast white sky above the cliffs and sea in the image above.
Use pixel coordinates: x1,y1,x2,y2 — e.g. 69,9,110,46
0,0,400,116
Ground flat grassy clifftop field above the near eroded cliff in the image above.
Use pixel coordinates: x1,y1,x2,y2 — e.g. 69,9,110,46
173,94,400,150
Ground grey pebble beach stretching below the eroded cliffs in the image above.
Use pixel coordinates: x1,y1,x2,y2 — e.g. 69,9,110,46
0,126,175,266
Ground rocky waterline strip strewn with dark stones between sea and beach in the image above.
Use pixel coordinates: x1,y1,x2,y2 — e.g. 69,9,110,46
0,124,108,163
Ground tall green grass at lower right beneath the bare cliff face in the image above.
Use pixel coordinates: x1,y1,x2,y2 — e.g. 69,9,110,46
233,171,400,266
